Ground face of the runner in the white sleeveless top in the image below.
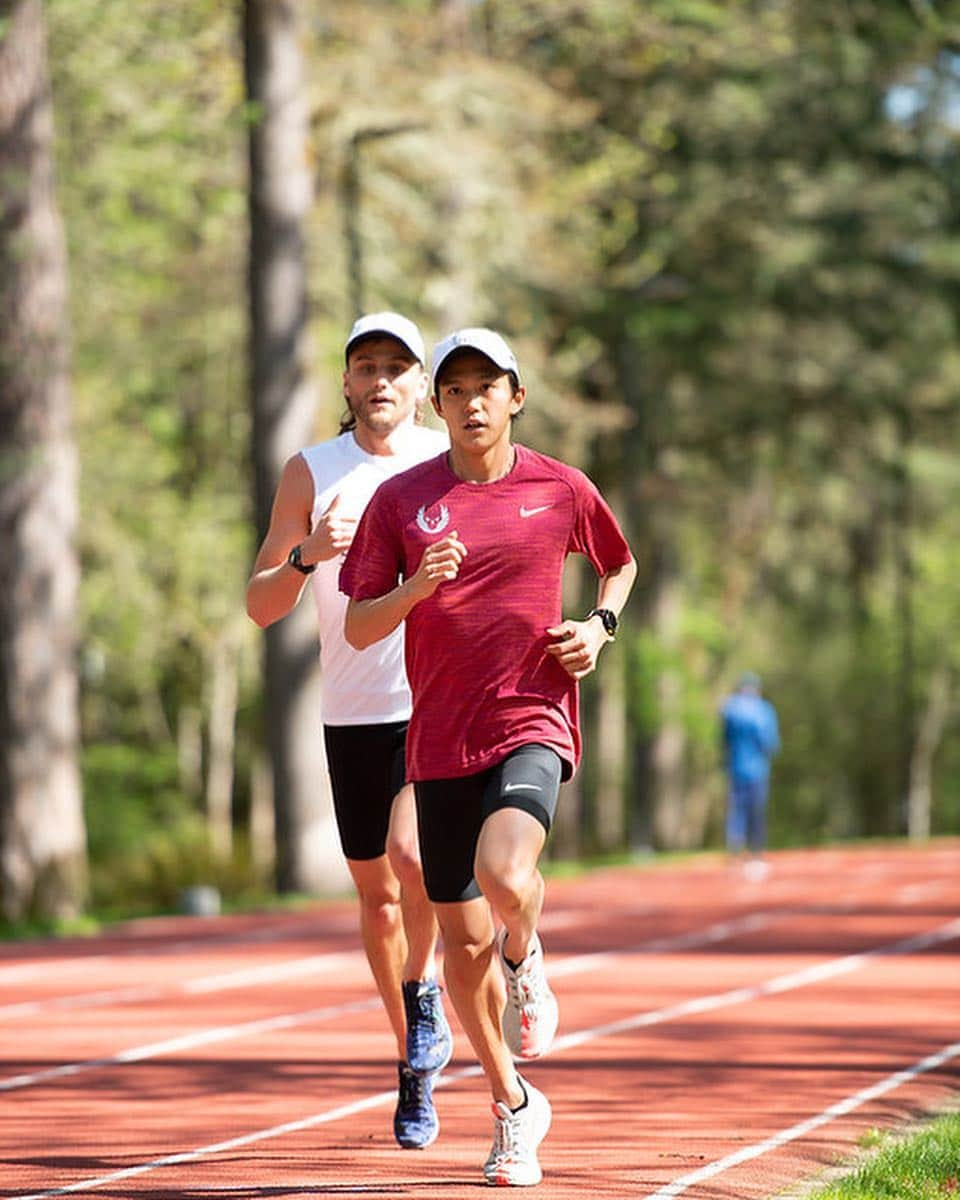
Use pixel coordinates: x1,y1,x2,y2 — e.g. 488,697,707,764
343,337,430,434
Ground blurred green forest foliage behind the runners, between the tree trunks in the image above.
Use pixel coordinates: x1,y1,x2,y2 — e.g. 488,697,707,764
39,0,960,902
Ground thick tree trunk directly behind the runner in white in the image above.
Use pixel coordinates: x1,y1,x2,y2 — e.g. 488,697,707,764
244,0,348,893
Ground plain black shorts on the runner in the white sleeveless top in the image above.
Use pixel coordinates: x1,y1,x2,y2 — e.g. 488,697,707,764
323,721,407,863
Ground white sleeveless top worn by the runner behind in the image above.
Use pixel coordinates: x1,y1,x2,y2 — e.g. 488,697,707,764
300,425,449,725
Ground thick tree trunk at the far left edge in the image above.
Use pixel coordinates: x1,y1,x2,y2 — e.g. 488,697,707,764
0,0,86,919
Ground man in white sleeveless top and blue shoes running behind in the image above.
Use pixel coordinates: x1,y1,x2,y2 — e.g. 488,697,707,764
247,312,452,1148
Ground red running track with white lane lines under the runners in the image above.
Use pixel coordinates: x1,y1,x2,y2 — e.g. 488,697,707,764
0,840,960,1200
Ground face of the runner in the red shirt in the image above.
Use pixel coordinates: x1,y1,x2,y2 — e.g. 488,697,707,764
433,350,526,454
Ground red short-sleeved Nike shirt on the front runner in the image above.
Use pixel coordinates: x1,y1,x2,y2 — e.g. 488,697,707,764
340,445,630,780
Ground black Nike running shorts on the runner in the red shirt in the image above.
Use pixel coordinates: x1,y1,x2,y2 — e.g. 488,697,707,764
414,745,563,904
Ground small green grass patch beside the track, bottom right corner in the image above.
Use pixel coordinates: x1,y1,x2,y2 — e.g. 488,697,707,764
804,1112,960,1200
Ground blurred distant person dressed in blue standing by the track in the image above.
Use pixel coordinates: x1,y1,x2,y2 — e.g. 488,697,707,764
720,671,780,877
